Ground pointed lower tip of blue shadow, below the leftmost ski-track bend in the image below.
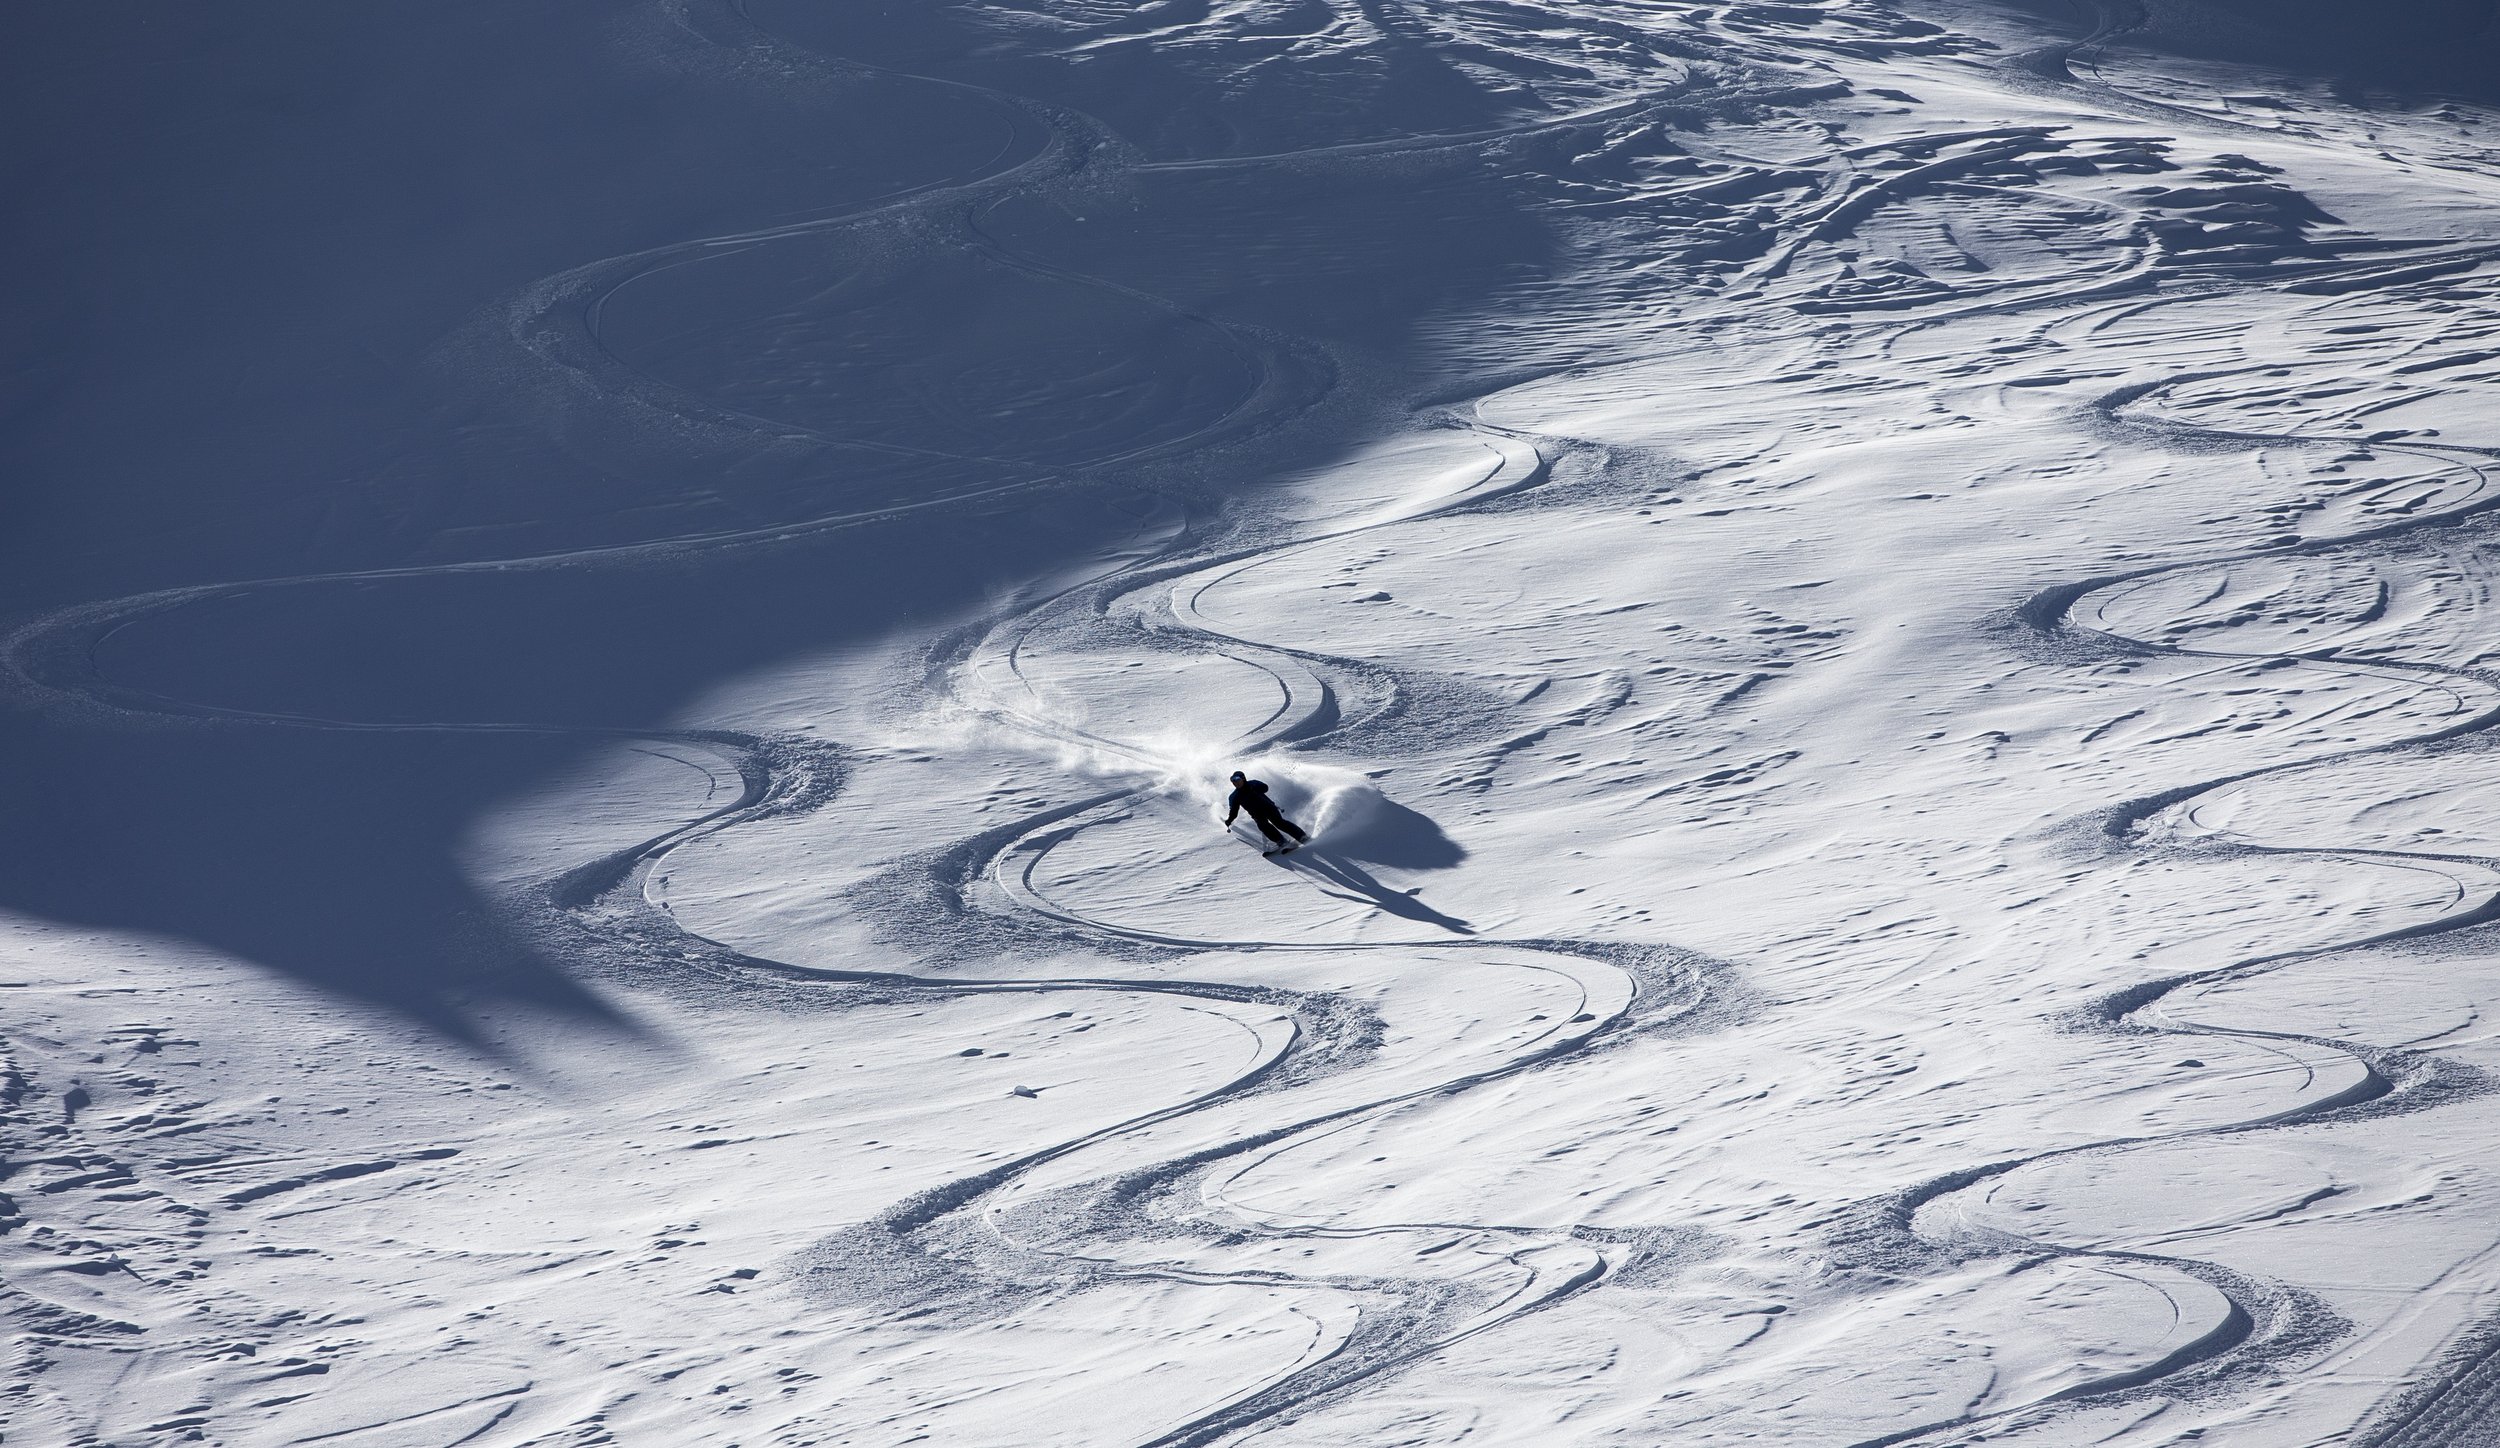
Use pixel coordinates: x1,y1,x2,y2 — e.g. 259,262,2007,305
0,720,610,1038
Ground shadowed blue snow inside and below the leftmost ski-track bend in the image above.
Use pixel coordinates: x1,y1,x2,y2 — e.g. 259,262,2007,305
0,500,1135,1040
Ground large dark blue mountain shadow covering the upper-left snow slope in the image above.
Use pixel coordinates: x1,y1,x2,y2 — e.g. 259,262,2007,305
0,0,1558,1033
